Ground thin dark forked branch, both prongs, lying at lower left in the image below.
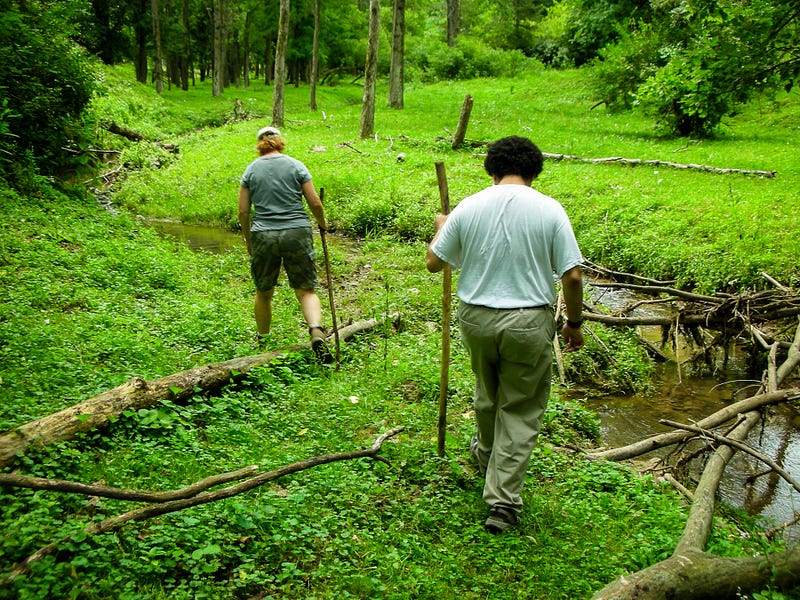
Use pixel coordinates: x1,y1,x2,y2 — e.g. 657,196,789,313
0,427,403,586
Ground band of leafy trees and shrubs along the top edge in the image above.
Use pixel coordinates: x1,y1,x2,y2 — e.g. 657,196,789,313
0,0,800,180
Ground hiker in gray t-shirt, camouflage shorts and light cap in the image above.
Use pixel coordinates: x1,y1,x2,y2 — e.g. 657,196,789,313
239,127,328,356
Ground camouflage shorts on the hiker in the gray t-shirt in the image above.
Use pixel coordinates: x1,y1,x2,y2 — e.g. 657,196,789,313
250,227,317,292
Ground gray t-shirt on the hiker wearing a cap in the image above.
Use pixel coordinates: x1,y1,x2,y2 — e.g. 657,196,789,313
240,154,311,231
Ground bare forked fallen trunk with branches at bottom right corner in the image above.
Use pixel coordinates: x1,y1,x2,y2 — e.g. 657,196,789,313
590,312,800,600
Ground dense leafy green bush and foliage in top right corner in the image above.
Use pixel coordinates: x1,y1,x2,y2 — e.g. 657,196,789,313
578,0,800,137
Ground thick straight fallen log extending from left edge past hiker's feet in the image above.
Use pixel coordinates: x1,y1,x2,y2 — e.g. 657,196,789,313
0,315,397,467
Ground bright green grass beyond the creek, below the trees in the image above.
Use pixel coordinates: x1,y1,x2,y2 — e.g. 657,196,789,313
106,63,800,292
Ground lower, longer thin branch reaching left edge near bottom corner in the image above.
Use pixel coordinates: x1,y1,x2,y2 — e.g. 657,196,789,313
0,427,404,587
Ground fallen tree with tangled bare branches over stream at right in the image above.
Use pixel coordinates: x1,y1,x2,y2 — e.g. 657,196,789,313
586,270,800,600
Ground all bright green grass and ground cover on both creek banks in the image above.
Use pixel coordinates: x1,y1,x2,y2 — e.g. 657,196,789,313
0,67,800,599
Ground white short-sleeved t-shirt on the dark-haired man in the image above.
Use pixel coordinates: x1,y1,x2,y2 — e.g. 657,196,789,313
431,184,583,309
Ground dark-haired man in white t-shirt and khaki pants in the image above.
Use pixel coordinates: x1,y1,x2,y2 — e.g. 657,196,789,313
425,136,584,533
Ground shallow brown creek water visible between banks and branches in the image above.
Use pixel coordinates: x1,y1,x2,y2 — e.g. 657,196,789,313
151,221,800,542
